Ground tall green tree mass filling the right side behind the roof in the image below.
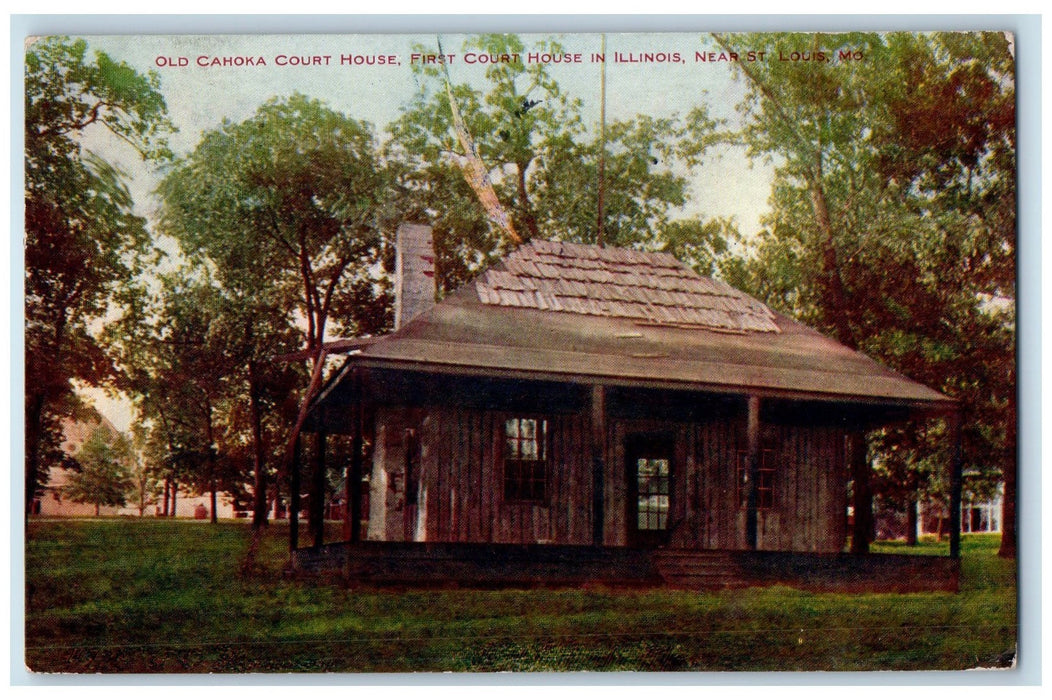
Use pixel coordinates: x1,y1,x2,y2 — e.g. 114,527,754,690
716,33,1015,552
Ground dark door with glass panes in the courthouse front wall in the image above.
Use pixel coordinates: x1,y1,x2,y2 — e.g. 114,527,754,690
625,433,674,546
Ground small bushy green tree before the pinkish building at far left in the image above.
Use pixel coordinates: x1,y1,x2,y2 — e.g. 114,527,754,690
62,427,136,516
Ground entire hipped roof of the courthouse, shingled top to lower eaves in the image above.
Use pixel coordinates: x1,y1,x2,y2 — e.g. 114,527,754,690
334,241,953,408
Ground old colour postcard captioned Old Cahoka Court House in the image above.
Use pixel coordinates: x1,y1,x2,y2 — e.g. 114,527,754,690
24,31,1018,674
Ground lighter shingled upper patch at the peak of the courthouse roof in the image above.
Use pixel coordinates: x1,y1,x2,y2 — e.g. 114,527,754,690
476,241,778,333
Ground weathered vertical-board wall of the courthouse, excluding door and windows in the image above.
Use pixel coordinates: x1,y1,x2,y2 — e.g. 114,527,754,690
368,406,847,552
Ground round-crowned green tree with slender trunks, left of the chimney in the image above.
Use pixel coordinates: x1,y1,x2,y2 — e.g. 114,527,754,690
153,95,390,530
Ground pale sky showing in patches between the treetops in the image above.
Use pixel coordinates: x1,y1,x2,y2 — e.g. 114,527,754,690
65,33,772,429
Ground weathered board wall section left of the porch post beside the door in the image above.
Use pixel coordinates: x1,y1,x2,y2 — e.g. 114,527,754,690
368,407,591,544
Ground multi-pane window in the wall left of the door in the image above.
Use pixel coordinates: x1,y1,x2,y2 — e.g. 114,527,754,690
501,414,551,505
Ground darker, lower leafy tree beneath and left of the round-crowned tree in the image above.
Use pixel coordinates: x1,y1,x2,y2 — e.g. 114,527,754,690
109,259,305,524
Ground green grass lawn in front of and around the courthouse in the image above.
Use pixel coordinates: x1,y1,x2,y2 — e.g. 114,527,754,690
25,519,1016,673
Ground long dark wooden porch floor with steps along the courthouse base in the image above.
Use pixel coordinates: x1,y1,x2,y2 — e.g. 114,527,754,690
295,542,960,593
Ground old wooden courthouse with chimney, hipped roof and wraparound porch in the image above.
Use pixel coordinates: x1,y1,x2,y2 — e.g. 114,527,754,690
294,224,960,591
